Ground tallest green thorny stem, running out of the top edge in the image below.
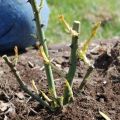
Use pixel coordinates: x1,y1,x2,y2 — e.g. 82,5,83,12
28,0,57,98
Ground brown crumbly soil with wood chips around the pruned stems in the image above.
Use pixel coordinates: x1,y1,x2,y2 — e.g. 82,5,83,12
0,40,120,120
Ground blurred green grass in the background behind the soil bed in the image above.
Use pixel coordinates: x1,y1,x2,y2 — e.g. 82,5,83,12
46,0,120,43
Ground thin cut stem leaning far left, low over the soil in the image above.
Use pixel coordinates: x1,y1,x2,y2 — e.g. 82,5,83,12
3,55,52,110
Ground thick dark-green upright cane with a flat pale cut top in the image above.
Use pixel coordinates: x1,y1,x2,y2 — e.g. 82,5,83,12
63,21,80,105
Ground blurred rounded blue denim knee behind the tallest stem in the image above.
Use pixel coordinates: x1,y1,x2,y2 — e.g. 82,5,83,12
0,0,49,52
